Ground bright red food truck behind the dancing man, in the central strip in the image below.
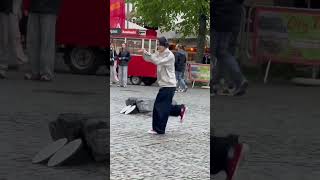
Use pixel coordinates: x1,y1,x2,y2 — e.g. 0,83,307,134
110,28,157,86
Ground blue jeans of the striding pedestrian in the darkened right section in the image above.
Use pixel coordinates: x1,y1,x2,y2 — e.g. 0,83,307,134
213,32,245,87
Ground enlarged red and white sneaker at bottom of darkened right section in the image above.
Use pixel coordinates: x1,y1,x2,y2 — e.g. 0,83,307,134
226,144,249,180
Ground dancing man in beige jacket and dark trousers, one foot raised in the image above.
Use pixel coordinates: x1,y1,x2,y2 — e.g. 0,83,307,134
140,37,188,134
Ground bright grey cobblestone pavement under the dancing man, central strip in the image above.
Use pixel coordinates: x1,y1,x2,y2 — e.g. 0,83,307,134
110,86,210,180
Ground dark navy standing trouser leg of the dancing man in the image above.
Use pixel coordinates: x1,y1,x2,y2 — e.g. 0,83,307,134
152,88,176,134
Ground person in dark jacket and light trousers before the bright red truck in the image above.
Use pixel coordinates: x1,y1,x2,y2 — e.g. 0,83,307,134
118,43,131,87
